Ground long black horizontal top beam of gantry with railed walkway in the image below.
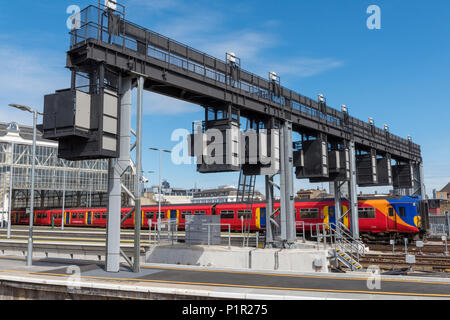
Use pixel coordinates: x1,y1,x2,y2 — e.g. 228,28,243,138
67,6,422,162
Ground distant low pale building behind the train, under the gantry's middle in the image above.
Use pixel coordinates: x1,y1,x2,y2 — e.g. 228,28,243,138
191,186,265,204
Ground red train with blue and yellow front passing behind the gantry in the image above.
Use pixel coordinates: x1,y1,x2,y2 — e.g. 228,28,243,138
12,197,427,235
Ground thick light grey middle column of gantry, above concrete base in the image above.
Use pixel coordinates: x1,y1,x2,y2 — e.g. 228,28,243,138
280,121,296,247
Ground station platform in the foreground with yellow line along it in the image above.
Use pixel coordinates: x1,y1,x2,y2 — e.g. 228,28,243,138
0,257,450,300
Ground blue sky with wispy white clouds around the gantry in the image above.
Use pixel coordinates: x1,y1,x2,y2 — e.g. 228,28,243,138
0,0,450,194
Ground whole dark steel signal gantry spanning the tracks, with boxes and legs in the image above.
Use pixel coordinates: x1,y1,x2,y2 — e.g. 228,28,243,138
40,4,424,271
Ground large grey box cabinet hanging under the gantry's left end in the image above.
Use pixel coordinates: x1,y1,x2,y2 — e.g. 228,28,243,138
42,89,119,161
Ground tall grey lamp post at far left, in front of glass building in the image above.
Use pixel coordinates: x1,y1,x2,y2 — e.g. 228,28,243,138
9,104,43,267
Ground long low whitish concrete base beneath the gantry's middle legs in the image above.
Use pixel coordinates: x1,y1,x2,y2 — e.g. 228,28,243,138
145,244,329,273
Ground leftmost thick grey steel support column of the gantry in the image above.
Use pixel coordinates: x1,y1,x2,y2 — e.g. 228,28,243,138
106,77,132,272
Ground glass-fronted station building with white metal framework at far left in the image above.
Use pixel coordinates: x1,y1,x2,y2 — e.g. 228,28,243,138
0,122,134,212
